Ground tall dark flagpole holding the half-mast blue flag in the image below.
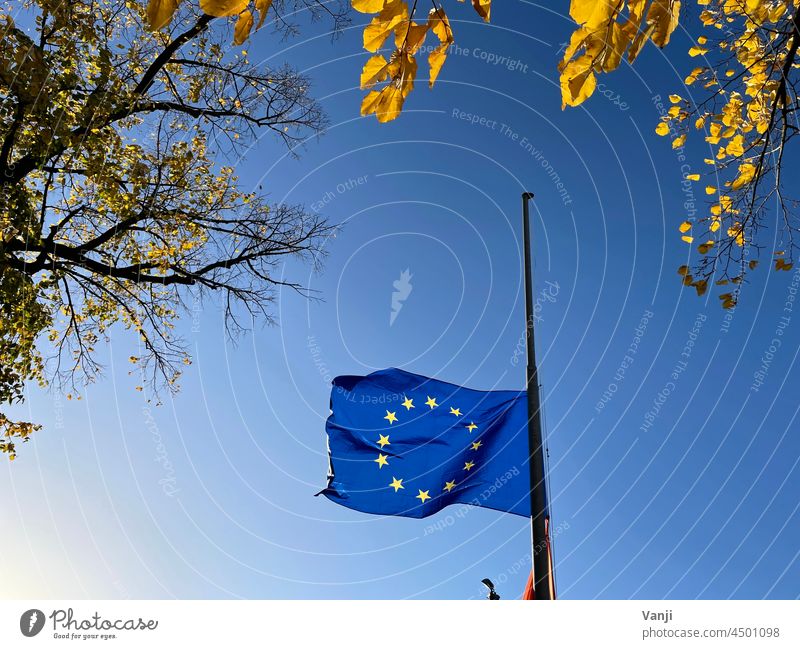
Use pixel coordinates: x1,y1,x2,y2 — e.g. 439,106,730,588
522,192,553,599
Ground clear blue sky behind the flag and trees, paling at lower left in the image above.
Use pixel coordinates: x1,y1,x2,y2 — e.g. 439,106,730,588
0,0,800,599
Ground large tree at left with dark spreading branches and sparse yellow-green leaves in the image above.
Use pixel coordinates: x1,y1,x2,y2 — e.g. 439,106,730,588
0,0,346,459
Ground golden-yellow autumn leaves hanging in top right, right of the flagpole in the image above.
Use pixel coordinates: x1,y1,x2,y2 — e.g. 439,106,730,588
560,0,800,309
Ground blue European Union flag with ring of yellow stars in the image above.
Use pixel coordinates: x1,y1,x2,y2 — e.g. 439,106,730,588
321,369,531,518
